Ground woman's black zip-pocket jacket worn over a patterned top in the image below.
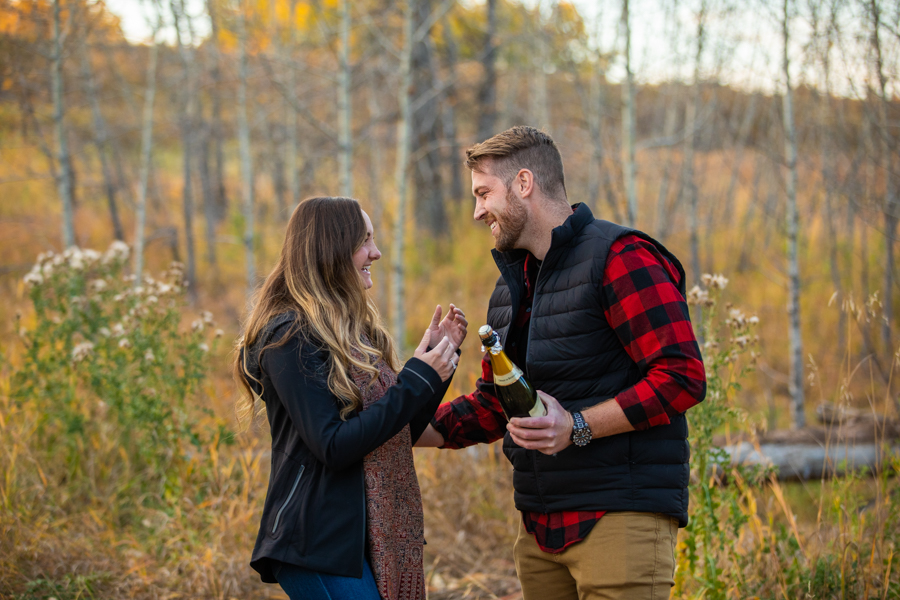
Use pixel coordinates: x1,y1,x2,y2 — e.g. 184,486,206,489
247,315,449,583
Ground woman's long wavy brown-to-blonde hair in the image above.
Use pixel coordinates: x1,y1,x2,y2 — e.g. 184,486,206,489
233,198,398,419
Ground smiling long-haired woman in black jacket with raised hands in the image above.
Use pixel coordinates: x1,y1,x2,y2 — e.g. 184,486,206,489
235,198,467,600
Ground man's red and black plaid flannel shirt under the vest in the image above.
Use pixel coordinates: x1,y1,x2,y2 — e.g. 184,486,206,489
432,235,706,553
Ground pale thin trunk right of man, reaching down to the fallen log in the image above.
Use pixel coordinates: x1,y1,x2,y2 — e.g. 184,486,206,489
781,0,806,428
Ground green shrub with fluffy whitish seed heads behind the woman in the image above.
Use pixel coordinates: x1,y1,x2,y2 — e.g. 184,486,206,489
10,242,221,506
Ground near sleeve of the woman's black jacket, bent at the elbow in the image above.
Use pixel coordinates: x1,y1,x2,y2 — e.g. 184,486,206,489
262,336,445,470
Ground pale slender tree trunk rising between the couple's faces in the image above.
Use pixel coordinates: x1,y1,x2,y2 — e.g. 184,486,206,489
391,0,415,354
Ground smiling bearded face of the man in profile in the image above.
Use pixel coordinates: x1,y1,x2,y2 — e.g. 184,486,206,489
472,171,528,252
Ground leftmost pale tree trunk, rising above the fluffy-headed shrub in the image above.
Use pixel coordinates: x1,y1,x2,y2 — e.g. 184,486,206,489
50,0,75,248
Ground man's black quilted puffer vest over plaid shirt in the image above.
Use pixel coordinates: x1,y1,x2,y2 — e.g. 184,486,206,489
488,204,690,527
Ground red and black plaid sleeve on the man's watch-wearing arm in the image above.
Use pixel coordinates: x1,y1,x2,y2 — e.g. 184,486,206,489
602,235,706,429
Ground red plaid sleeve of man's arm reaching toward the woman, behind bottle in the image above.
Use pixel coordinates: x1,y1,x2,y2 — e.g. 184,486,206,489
431,354,507,449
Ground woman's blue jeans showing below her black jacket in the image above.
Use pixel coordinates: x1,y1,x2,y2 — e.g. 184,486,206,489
274,561,381,600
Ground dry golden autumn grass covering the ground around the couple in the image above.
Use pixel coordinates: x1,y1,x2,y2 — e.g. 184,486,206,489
0,125,900,600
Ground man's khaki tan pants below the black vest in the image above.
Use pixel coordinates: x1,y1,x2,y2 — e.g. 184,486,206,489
514,512,678,600
